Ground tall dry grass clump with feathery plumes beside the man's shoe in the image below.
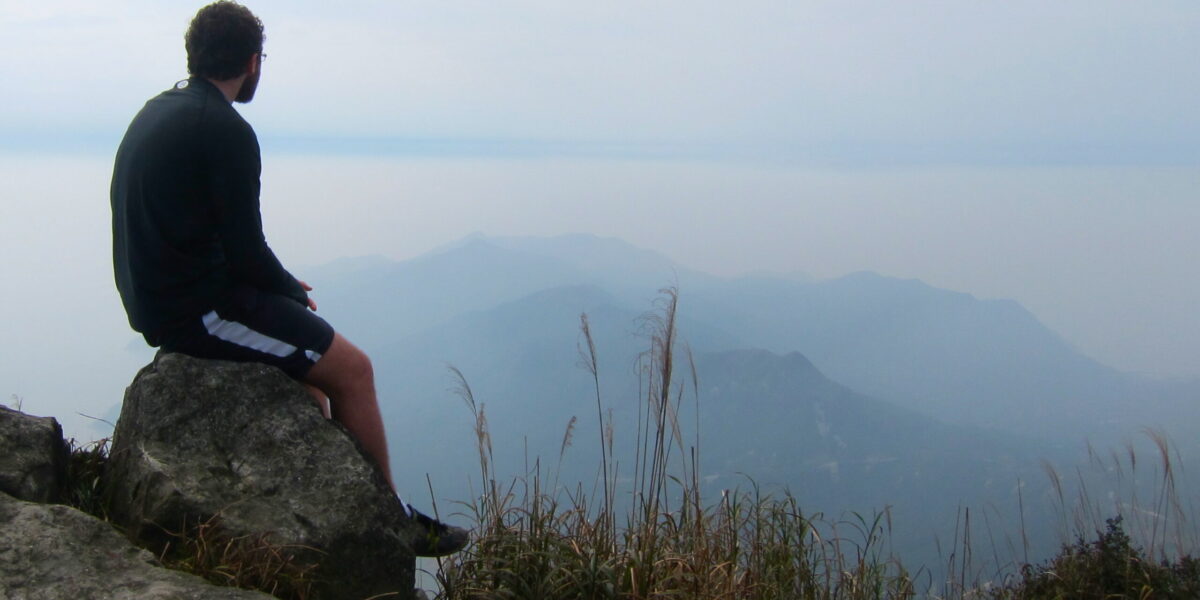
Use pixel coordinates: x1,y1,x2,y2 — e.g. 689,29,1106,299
438,289,916,600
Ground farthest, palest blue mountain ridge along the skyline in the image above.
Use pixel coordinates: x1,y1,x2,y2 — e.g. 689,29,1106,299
311,234,1200,444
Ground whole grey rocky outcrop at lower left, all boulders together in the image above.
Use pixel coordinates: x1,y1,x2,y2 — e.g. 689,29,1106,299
0,354,425,600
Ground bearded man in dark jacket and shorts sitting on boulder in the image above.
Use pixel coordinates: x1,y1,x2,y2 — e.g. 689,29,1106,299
110,1,468,556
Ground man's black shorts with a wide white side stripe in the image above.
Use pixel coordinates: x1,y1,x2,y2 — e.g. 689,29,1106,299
162,286,334,380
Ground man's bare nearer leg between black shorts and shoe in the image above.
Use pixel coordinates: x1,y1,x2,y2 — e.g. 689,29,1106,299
305,334,396,491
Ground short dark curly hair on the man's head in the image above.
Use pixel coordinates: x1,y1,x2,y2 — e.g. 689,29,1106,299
184,0,266,82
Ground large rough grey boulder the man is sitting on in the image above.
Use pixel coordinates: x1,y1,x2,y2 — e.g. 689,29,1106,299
106,353,419,599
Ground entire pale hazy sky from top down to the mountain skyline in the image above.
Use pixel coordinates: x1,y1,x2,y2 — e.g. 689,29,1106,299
0,0,1200,436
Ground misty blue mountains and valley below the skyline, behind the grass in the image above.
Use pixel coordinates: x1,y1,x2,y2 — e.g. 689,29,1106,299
292,235,1200,577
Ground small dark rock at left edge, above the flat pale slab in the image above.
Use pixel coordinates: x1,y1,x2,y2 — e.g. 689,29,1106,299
0,407,67,502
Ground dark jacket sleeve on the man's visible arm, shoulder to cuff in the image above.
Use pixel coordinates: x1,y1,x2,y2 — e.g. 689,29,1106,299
205,111,308,306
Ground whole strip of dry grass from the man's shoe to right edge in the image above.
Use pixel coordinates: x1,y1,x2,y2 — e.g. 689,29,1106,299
436,289,1200,600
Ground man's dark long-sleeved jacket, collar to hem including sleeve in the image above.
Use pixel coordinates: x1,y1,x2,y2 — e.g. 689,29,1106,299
109,77,308,346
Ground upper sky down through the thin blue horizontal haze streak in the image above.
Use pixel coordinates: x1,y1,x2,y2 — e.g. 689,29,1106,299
0,0,1200,164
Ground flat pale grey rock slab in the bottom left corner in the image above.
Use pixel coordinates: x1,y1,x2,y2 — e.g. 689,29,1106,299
0,493,271,600
